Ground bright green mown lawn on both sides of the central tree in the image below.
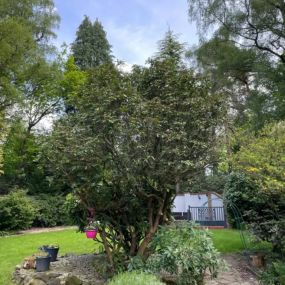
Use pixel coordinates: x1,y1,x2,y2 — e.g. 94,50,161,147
0,226,268,285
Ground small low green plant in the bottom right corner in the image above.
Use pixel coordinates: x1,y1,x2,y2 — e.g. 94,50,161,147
260,261,285,285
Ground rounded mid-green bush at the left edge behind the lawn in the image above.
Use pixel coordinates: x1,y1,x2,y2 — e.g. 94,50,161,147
0,190,36,231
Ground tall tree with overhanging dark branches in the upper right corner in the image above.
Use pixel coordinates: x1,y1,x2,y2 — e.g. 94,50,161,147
188,0,285,130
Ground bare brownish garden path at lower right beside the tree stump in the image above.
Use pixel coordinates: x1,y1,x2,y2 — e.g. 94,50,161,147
206,254,259,285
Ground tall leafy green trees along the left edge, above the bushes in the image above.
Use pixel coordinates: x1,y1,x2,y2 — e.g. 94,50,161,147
0,0,61,193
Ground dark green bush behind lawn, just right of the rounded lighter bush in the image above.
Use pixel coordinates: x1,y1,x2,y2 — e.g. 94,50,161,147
33,194,71,227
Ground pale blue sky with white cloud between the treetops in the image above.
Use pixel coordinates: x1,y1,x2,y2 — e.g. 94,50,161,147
54,0,198,64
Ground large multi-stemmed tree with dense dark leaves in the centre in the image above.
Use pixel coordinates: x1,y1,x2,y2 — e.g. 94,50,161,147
49,34,223,266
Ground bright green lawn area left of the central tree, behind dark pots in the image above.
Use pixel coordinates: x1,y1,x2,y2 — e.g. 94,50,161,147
0,229,100,285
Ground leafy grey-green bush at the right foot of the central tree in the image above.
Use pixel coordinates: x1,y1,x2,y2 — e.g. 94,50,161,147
141,222,222,285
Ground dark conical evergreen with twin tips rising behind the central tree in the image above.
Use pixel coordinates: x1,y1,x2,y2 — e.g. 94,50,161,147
72,16,112,70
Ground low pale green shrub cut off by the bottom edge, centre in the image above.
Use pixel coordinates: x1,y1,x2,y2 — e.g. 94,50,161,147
108,271,164,285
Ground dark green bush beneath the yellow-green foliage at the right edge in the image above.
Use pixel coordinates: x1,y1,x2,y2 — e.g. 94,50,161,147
225,173,285,254
